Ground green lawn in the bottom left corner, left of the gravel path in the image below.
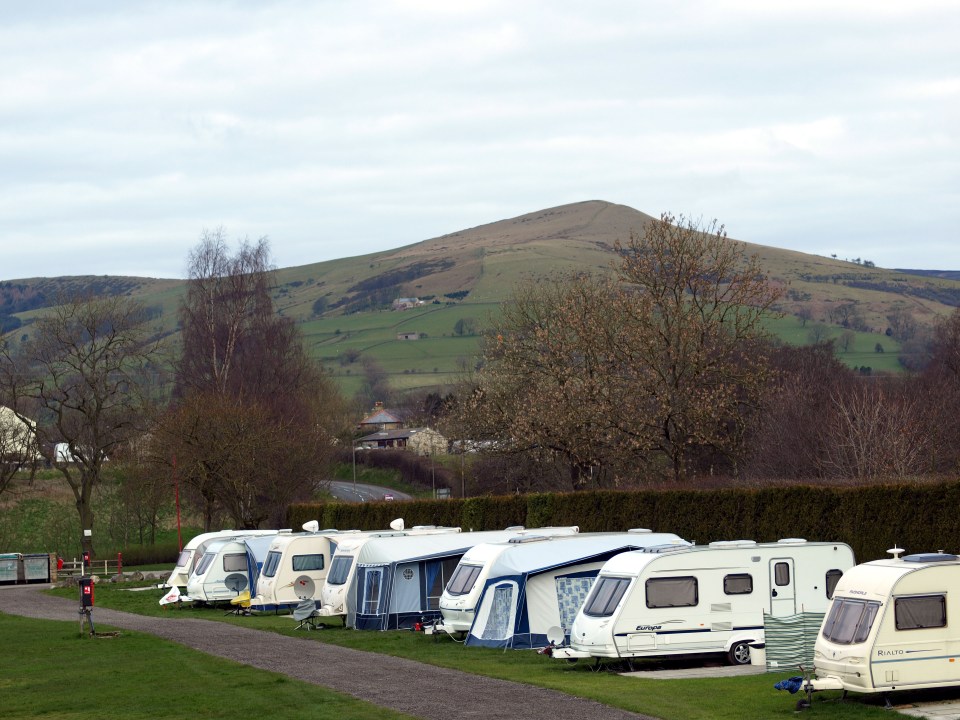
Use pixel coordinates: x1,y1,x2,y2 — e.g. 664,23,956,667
0,612,409,720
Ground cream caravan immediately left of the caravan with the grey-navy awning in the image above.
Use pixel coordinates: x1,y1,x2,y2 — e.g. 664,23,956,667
251,518,460,610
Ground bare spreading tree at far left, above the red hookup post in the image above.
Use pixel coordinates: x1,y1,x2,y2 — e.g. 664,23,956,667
0,296,162,552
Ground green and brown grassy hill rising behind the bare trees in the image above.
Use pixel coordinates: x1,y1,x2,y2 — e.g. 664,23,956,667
0,201,960,393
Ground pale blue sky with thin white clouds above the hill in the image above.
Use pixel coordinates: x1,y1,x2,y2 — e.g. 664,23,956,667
0,0,960,280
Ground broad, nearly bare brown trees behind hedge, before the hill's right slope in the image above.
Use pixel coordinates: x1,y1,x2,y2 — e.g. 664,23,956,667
458,215,779,486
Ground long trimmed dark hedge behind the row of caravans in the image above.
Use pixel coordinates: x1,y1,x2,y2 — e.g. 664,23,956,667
288,482,960,562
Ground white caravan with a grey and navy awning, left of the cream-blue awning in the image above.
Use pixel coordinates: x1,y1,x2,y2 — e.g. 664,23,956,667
320,526,579,630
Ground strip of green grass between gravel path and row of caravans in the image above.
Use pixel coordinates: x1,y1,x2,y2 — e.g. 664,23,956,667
33,585,904,720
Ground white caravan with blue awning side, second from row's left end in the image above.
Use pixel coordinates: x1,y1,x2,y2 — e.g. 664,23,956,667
183,530,290,603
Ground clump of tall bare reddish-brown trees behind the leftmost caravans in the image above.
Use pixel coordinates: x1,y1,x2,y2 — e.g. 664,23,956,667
151,230,346,528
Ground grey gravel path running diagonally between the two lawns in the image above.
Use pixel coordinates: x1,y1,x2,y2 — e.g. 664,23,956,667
0,585,655,720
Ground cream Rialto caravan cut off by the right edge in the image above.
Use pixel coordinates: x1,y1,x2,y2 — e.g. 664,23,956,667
804,548,960,693
